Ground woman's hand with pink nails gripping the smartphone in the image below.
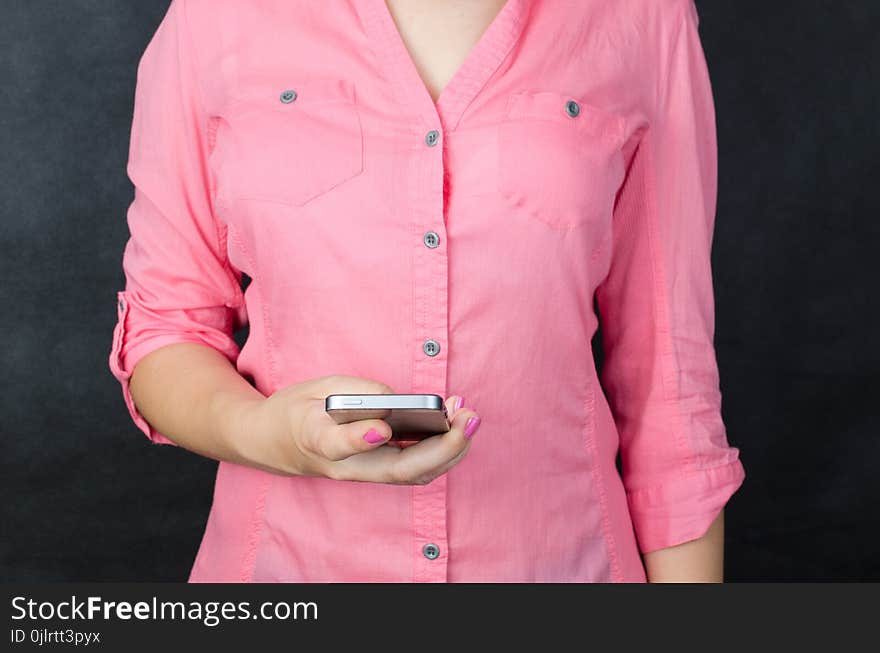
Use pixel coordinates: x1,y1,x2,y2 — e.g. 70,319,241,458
239,375,479,485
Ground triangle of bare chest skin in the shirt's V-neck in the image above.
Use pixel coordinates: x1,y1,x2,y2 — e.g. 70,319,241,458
385,0,505,102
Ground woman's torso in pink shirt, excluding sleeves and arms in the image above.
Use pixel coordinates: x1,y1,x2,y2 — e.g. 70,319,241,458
188,0,680,581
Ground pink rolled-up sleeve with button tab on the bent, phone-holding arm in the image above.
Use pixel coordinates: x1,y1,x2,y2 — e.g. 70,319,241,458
109,0,247,444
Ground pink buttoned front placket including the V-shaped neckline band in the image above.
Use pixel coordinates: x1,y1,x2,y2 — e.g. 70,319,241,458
355,0,528,582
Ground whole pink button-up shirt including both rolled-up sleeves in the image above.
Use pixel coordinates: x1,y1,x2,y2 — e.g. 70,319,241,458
109,0,744,582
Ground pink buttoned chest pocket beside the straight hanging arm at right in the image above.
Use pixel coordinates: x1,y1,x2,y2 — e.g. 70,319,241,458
496,91,624,229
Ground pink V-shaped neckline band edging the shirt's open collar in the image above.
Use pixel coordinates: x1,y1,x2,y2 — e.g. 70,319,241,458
357,0,528,130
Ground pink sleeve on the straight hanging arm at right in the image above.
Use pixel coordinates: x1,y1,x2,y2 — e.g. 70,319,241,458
596,0,745,553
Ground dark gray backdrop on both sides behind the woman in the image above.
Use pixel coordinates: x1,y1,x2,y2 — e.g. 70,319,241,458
0,0,880,581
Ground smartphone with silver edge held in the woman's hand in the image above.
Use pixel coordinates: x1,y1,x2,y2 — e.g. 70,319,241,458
324,394,451,442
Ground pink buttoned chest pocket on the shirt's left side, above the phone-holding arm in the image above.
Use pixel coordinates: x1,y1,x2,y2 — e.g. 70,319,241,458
214,76,364,206
